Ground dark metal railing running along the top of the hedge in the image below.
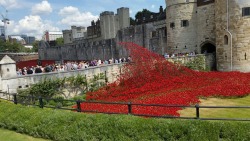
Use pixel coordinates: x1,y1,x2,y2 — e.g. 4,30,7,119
0,93,250,121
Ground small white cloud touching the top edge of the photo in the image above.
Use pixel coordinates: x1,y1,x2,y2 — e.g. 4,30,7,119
31,1,53,15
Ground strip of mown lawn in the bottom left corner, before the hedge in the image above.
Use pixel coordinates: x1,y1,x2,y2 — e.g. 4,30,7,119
0,128,49,141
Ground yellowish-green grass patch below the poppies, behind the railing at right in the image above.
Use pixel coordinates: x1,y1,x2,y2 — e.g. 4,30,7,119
179,95,250,119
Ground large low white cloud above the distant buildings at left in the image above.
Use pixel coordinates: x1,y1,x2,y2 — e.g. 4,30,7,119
8,15,59,39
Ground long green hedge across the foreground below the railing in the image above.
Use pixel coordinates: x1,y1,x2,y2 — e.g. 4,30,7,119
0,101,250,141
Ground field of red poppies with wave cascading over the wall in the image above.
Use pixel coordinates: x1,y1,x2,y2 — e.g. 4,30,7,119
81,43,250,116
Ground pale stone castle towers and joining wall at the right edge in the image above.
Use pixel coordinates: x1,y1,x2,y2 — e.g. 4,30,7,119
166,0,250,72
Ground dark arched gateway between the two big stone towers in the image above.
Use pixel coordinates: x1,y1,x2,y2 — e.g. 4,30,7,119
200,42,217,71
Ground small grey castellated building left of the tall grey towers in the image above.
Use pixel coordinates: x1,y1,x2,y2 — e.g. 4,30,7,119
62,26,87,44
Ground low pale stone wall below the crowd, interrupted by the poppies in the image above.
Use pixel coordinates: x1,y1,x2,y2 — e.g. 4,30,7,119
0,54,214,93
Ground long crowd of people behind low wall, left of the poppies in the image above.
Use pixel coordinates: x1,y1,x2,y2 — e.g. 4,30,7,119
17,57,131,76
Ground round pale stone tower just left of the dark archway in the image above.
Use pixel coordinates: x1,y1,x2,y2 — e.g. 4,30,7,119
166,0,197,53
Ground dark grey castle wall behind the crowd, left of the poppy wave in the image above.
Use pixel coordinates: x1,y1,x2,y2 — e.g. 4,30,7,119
38,39,118,61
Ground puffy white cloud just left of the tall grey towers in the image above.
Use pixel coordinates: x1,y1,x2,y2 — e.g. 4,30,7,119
59,6,98,27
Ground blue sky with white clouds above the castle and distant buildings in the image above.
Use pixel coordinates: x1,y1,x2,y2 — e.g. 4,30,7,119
0,0,166,39
